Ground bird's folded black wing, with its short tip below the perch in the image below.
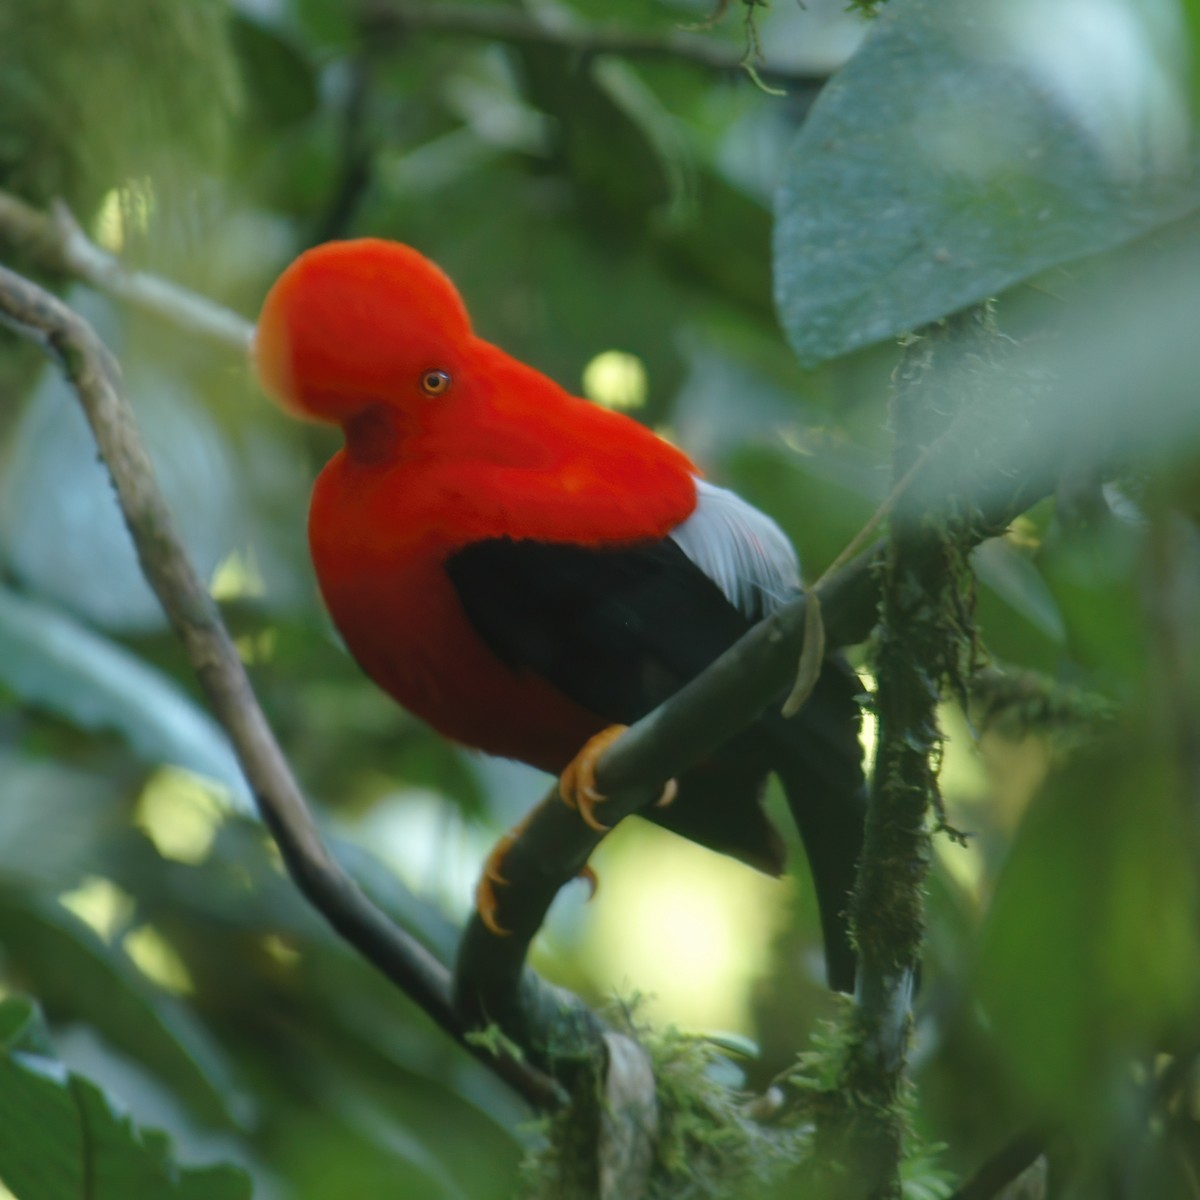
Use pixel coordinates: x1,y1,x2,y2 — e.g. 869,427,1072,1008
446,538,785,875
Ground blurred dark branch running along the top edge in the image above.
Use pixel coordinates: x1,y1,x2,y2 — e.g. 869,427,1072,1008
361,0,828,88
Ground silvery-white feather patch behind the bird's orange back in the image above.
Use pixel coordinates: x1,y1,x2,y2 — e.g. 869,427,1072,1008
671,479,800,620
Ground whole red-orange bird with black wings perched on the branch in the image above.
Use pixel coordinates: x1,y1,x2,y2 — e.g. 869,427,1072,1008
257,239,865,990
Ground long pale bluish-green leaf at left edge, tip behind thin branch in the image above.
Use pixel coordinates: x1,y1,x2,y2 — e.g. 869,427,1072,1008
0,588,248,804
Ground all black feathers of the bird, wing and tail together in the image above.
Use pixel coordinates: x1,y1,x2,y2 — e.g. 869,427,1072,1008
446,523,865,990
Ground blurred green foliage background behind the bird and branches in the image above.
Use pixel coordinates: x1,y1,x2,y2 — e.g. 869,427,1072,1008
0,0,1200,1200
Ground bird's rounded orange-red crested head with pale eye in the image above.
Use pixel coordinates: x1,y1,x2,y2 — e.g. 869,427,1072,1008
254,238,472,432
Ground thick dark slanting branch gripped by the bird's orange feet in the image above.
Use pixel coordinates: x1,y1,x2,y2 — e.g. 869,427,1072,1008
455,379,1056,1055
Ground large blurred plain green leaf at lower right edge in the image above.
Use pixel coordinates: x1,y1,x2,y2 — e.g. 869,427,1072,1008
976,727,1200,1127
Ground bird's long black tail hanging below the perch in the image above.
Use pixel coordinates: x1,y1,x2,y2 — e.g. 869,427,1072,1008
763,658,866,992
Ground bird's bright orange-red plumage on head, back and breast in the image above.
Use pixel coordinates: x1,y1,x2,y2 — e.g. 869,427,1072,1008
257,239,696,772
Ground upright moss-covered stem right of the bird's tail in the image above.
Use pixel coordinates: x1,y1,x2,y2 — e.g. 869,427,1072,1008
822,307,1037,1200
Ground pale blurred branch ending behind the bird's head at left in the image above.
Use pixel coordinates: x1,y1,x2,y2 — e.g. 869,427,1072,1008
0,191,254,354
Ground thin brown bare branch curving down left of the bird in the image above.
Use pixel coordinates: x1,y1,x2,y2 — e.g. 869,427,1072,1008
0,266,559,1106
